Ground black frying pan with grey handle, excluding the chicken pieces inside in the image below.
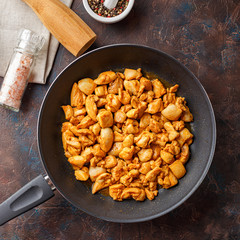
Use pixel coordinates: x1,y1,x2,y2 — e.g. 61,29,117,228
0,44,216,224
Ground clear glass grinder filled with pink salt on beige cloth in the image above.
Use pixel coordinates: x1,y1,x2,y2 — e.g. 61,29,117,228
0,29,45,112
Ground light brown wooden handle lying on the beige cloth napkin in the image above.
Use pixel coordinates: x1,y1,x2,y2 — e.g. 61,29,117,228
23,0,96,56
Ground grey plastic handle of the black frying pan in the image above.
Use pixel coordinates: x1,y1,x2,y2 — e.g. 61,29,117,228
0,175,54,226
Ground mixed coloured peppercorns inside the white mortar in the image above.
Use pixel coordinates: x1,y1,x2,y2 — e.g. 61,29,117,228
88,0,129,18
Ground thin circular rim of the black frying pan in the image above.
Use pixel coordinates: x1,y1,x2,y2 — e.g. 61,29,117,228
37,43,217,223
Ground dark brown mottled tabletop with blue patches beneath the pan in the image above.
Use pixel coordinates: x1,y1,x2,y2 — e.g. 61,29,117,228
0,0,240,240
